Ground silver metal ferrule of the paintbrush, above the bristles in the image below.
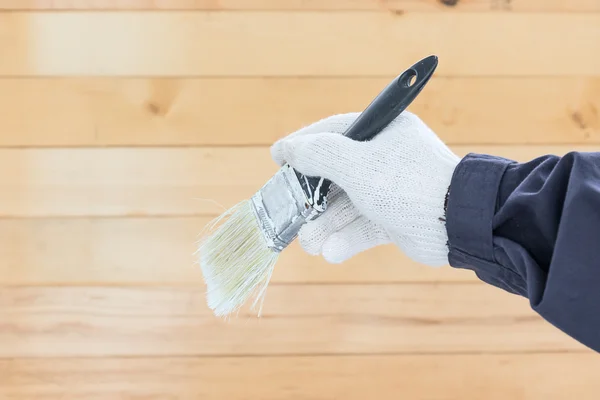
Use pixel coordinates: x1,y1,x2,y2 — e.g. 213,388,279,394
250,164,327,252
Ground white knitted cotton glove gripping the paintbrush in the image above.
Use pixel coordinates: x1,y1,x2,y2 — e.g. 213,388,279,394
271,111,460,266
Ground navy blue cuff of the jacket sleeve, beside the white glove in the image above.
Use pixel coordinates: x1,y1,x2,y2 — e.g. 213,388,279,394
446,153,514,268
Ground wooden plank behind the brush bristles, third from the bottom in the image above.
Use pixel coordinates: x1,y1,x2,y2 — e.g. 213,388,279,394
0,218,477,286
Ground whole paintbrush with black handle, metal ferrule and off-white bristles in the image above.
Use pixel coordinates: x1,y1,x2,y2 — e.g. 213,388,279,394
197,55,438,316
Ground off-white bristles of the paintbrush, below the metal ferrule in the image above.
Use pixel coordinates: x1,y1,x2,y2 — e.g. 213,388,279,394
198,200,279,316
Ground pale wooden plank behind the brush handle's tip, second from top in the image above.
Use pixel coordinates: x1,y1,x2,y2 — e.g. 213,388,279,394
0,11,600,76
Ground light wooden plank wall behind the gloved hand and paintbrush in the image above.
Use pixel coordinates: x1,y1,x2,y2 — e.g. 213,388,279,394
0,0,600,400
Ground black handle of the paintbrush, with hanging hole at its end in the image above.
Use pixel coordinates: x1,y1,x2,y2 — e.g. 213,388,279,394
295,55,438,208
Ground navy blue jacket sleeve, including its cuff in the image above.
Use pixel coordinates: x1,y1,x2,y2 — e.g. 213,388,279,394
446,152,600,352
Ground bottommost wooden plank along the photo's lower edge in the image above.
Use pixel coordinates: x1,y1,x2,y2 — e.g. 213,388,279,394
0,354,600,400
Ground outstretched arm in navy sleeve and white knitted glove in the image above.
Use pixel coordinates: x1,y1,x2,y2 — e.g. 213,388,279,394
271,111,600,352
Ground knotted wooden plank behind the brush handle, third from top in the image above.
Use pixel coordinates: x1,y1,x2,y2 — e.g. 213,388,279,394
0,76,600,146
